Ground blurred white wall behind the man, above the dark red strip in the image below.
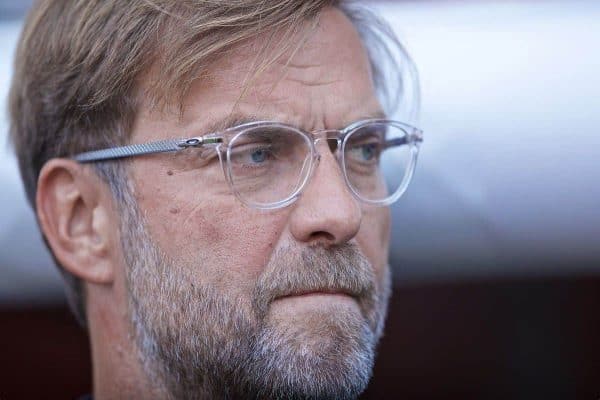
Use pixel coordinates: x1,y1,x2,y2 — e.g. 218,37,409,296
0,0,600,303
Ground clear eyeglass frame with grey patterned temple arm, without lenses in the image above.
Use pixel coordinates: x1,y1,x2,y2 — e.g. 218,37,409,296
72,119,423,210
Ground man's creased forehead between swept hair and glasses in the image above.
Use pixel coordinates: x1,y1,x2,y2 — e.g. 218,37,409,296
137,8,381,138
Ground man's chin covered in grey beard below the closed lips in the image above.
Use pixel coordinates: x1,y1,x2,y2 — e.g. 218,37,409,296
236,305,376,399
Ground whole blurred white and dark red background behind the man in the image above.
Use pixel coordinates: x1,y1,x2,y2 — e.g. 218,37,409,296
0,0,600,400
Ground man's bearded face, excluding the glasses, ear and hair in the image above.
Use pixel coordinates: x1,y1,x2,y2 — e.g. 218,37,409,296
121,10,389,398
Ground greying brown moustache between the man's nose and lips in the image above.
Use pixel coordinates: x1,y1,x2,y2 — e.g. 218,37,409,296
253,243,376,317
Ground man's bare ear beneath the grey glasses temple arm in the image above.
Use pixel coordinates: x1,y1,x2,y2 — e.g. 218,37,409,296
36,158,117,284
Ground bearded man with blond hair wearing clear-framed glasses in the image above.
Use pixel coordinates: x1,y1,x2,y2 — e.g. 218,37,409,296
10,0,420,399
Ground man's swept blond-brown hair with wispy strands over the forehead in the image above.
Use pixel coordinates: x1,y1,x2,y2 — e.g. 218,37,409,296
9,0,412,323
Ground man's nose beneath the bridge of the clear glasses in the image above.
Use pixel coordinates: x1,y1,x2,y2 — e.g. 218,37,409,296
290,140,362,247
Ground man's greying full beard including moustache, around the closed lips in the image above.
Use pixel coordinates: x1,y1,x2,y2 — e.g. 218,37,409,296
121,199,390,399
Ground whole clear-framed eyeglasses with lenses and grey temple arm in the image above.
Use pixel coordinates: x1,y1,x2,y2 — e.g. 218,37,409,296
74,119,423,210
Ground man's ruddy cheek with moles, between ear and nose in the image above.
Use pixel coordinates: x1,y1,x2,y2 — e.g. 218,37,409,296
138,170,286,292
